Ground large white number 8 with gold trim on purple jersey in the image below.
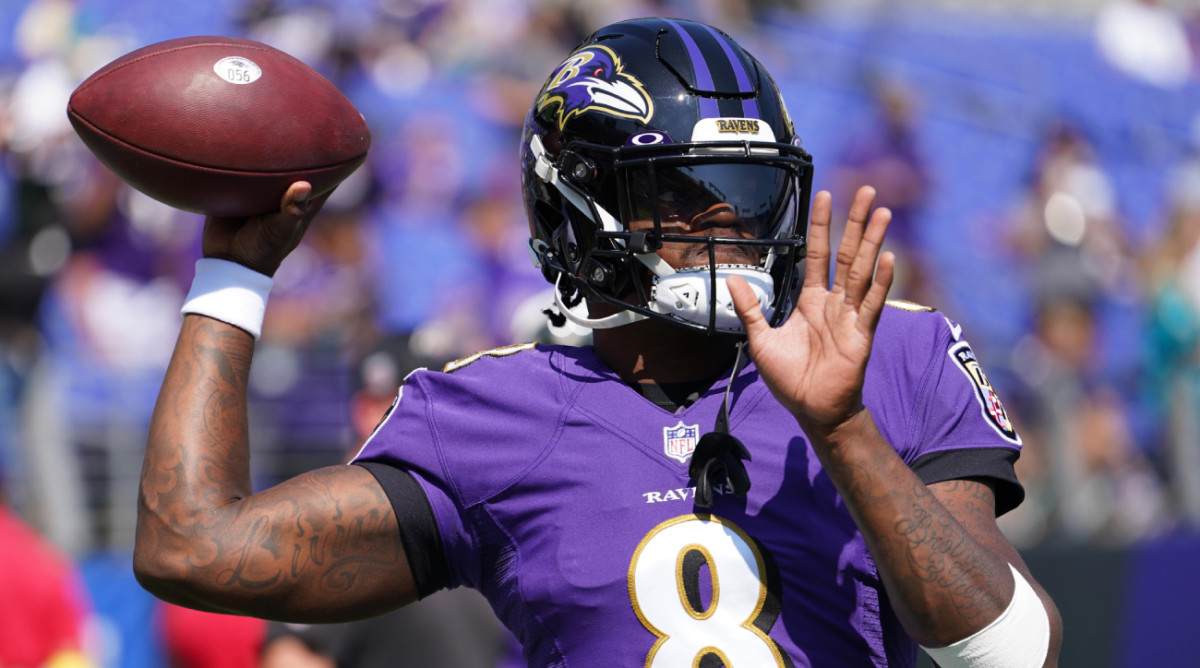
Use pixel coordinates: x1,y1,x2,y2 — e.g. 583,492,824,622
629,513,792,668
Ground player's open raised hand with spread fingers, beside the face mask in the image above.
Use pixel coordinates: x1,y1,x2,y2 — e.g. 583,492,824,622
728,186,895,435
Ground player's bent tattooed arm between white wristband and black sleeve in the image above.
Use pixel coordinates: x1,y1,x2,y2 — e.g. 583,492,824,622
134,315,415,622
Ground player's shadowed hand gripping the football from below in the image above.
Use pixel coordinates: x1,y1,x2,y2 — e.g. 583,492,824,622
203,181,329,276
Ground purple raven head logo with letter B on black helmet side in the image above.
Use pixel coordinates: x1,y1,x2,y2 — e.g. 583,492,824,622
538,46,654,130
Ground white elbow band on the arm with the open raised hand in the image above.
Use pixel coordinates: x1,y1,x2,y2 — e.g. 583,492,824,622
922,564,1050,668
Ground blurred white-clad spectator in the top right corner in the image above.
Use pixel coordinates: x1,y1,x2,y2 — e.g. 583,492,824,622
1096,0,1192,89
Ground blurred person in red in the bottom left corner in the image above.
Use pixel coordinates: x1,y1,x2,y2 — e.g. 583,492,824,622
0,494,95,668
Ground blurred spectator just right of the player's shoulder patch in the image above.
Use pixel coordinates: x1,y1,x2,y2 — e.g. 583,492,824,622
1002,291,1170,547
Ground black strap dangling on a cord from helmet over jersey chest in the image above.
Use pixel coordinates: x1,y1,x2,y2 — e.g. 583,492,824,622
688,341,750,508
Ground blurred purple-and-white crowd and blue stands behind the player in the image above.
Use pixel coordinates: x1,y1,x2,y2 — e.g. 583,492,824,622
0,0,1200,664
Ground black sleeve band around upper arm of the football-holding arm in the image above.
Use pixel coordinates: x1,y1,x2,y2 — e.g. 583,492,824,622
355,462,450,598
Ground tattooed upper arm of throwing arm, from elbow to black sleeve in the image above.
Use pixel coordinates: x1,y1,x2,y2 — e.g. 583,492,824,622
194,465,416,622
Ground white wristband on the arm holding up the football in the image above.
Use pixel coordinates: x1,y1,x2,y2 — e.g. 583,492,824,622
181,258,275,341
